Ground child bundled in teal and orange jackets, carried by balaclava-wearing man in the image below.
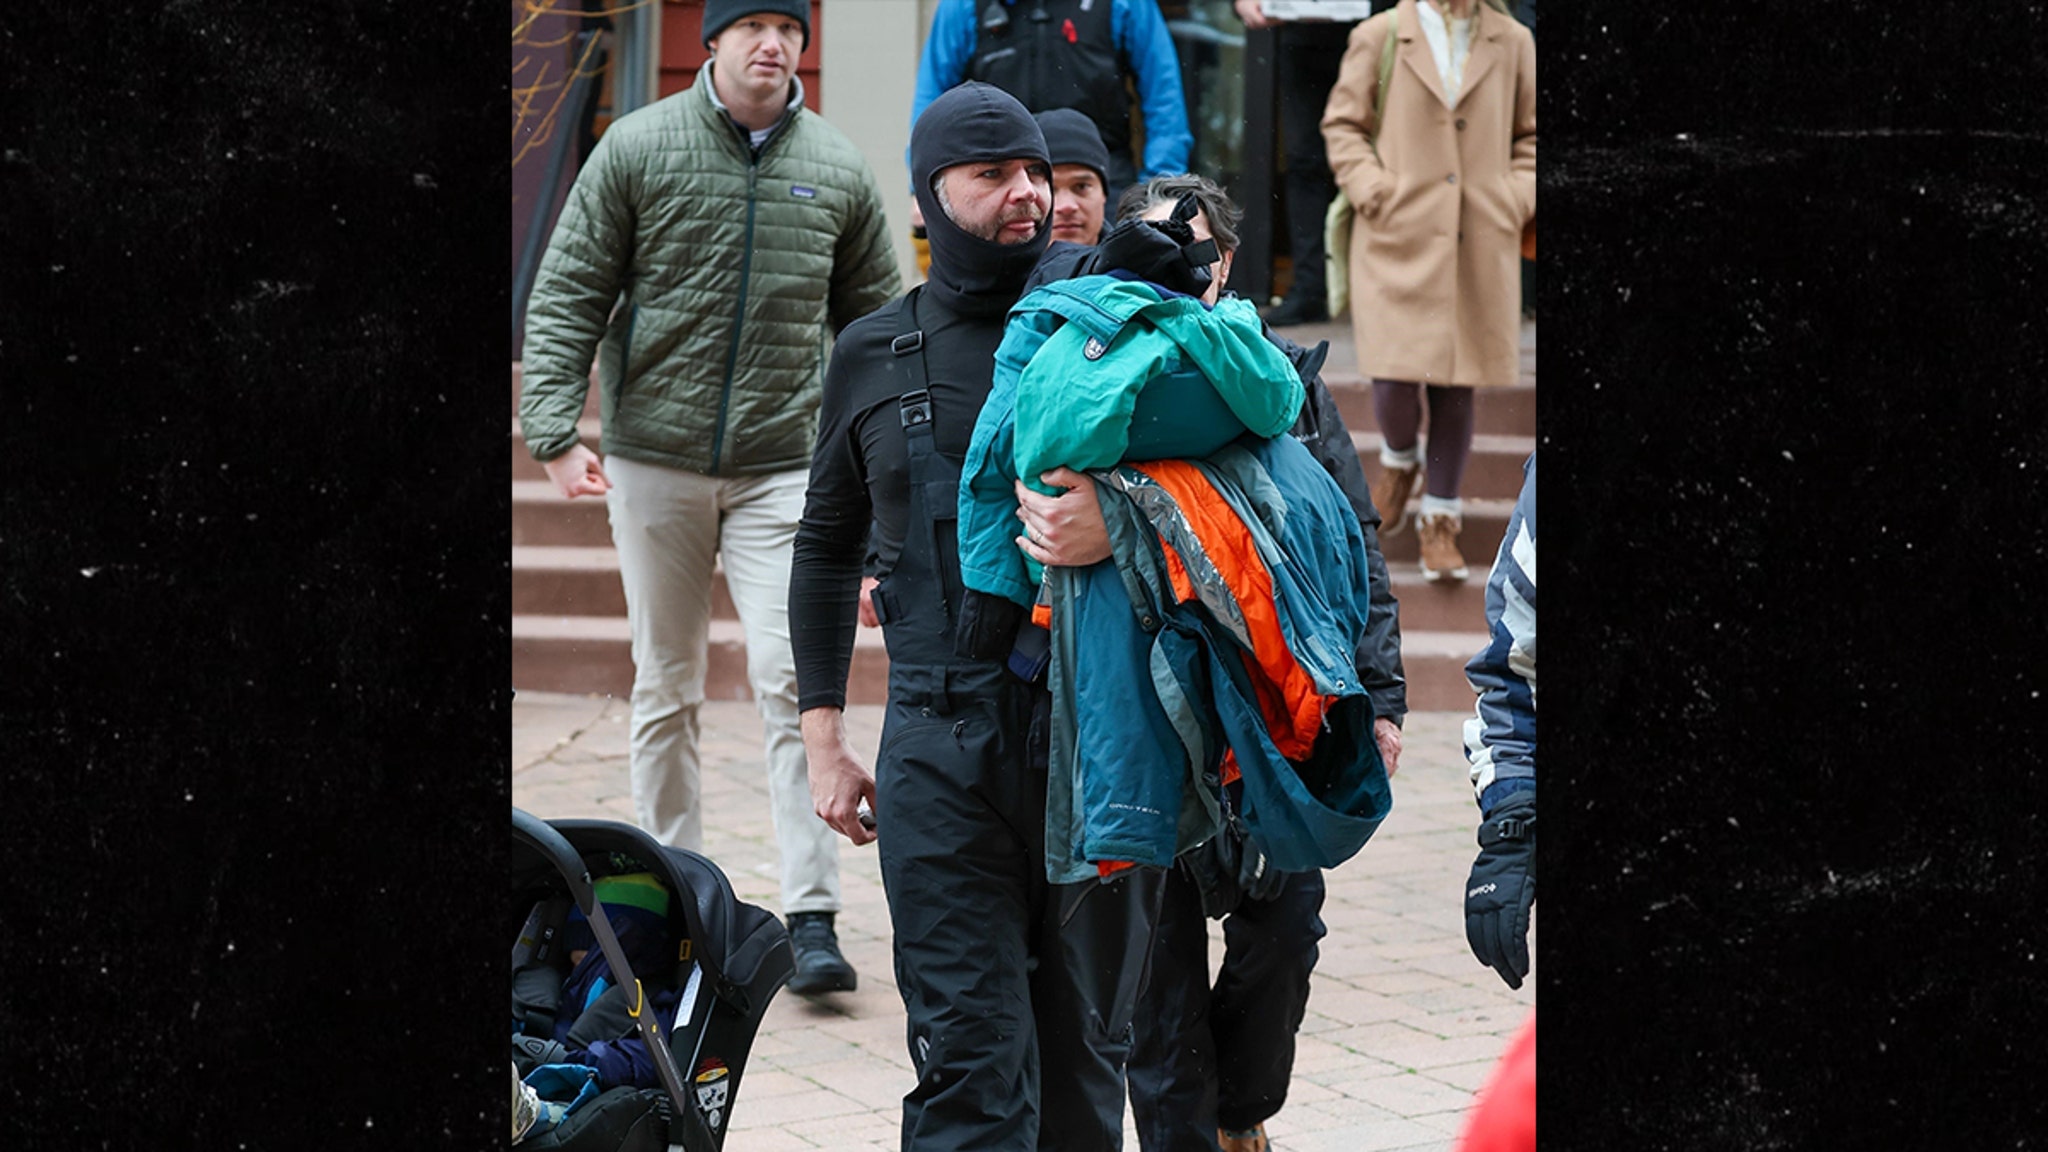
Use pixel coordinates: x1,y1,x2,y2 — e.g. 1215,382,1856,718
958,201,1391,883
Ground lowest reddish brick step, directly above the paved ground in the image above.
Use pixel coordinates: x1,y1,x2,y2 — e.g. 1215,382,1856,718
512,615,1487,711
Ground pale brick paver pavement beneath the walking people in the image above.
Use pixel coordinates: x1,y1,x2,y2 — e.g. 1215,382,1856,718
512,693,1536,1152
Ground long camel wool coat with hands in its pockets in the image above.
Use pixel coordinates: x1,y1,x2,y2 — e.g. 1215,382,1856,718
1323,0,1536,385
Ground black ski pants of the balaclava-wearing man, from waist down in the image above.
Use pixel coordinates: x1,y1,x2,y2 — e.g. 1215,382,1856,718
874,662,1165,1152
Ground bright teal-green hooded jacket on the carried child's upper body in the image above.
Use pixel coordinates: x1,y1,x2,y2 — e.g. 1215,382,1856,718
961,277,1305,605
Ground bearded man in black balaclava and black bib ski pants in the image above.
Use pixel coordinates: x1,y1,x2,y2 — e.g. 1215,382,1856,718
791,84,1161,1152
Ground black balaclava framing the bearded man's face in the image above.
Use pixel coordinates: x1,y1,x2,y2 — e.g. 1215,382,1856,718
909,80,1053,316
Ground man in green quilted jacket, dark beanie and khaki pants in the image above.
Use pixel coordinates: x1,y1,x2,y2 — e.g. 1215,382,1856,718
520,0,901,994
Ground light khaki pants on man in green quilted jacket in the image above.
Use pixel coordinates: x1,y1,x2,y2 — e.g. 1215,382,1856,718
604,455,840,916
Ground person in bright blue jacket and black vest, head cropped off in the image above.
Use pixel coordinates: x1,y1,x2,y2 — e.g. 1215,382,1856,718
909,0,1194,203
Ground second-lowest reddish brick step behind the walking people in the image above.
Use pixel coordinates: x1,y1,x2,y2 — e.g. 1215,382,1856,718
512,545,1493,631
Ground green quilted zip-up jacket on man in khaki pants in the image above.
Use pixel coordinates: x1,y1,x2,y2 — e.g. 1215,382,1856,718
518,64,901,476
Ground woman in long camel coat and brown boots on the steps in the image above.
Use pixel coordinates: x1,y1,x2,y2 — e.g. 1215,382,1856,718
1323,0,1536,580
